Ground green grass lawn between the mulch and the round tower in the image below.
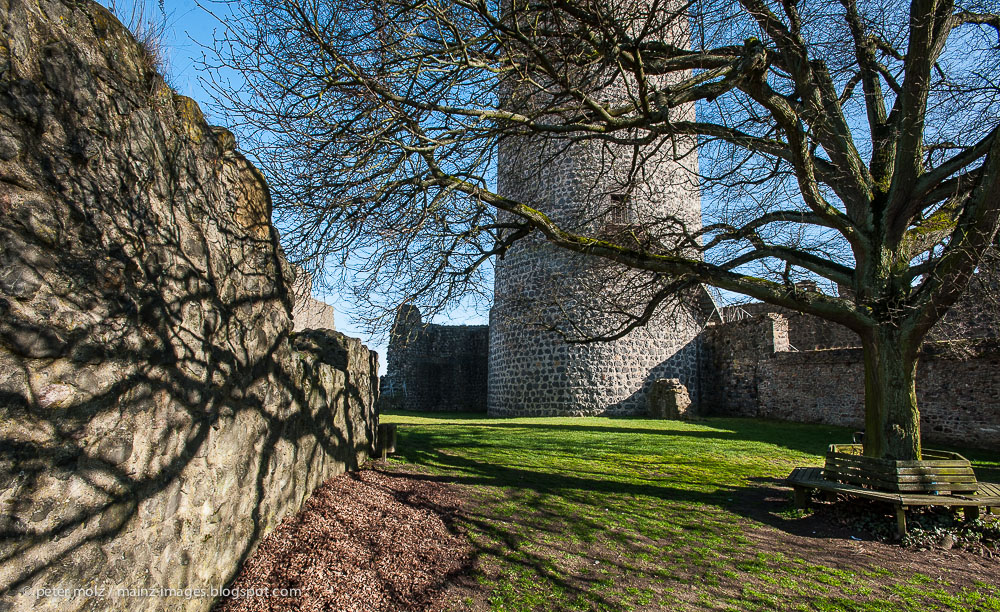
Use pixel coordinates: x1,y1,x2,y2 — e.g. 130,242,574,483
382,413,1000,612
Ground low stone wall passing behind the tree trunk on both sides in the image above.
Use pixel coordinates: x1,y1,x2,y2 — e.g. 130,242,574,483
755,349,1000,449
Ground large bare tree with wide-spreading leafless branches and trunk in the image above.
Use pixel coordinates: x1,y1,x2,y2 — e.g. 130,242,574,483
205,0,1000,459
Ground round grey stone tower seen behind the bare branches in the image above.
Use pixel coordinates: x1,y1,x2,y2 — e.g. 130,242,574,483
488,0,711,416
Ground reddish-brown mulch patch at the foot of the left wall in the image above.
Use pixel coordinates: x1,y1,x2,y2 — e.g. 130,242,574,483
214,469,472,612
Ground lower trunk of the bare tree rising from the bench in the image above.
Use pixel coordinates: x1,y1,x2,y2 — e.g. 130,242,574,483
862,325,920,460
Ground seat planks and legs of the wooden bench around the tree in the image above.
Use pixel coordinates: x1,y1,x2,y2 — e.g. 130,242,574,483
785,467,1000,538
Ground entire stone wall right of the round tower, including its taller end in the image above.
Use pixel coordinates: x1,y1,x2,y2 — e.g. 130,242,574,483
702,307,1000,449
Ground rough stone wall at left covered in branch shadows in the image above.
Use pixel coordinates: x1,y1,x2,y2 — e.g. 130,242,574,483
0,0,377,611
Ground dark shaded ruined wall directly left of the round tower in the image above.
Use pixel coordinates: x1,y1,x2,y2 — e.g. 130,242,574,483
381,306,489,412
